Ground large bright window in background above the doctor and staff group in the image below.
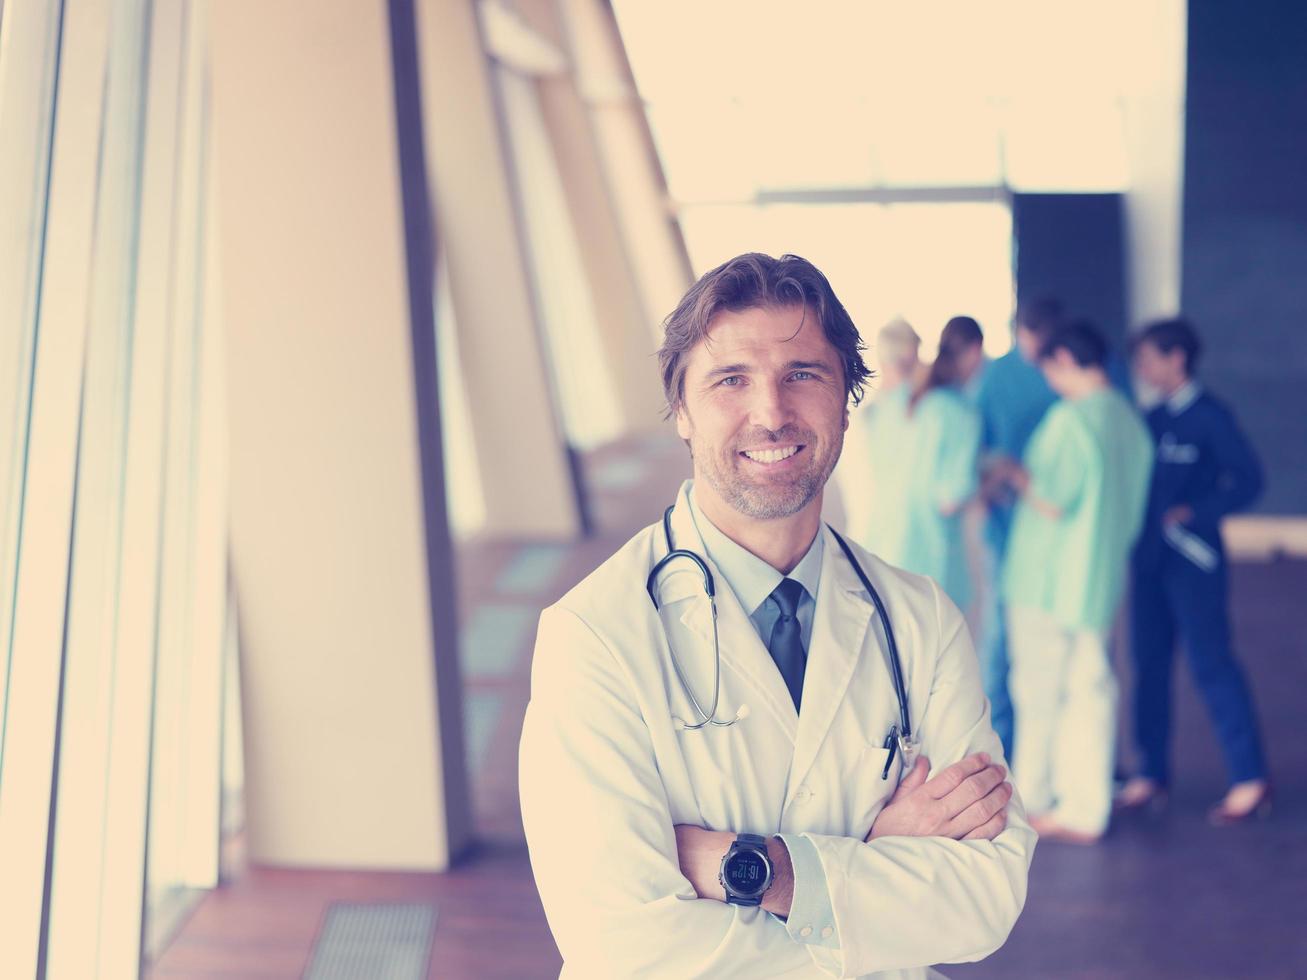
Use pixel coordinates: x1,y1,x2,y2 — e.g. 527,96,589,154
613,0,1132,366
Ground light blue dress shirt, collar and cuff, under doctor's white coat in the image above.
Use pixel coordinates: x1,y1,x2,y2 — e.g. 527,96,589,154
689,486,839,950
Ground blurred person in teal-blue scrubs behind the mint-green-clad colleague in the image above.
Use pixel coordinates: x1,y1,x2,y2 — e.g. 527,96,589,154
976,297,1063,757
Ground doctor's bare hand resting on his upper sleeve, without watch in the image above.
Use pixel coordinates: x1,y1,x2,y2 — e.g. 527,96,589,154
867,753,1012,840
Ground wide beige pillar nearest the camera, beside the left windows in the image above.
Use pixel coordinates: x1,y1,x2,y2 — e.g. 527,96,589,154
212,0,467,869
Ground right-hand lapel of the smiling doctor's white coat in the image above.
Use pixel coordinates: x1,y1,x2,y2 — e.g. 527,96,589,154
786,525,873,806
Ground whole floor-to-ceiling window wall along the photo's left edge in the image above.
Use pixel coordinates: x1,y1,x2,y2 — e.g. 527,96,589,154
0,0,227,980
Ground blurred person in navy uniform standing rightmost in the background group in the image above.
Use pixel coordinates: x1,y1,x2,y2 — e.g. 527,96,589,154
1117,319,1270,825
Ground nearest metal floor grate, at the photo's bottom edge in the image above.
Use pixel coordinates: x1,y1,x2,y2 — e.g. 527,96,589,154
305,902,435,980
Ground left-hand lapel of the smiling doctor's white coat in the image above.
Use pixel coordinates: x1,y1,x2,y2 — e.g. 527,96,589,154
669,481,799,742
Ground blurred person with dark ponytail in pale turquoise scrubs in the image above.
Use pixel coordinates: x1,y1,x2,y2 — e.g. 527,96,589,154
899,316,984,610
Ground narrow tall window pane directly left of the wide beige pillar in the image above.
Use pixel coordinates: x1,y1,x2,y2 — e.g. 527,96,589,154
146,0,227,954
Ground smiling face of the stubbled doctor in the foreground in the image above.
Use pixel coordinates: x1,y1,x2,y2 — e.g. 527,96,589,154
676,306,848,520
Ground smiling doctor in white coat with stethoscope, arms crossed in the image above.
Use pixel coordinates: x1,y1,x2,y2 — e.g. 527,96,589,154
520,255,1034,979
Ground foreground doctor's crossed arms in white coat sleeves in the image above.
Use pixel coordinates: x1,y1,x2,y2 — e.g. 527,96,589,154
520,602,1034,980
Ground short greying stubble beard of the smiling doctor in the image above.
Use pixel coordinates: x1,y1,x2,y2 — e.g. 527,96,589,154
689,426,843,520
